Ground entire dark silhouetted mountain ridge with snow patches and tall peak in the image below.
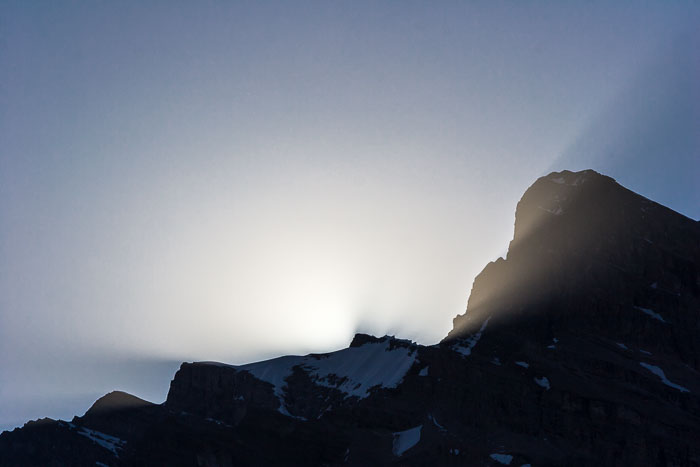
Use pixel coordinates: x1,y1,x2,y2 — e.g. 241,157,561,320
0,170,700,466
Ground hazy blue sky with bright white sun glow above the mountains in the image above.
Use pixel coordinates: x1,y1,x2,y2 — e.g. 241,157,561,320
0,1,700,429
